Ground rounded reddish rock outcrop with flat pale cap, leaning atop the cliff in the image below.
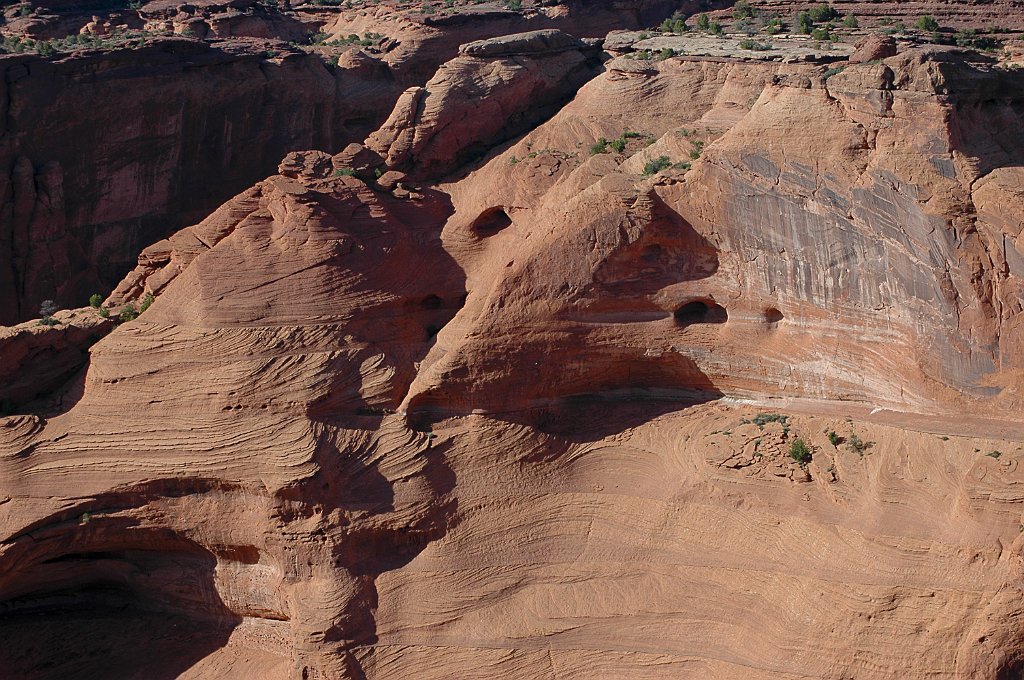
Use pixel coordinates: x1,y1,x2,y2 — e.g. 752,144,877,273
367,30,598,178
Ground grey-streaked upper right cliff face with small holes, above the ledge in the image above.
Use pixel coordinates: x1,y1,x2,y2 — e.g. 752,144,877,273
409,49,1024,413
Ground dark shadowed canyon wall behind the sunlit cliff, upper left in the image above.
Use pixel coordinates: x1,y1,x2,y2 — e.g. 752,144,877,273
0,40,397,324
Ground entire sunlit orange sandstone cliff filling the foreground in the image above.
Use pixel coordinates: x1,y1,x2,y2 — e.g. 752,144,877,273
0,5,1024,680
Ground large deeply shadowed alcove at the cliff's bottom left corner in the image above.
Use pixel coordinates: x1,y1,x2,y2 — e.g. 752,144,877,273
0,525,241,679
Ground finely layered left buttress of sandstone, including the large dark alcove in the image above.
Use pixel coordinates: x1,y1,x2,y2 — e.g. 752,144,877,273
0,153,465,678
